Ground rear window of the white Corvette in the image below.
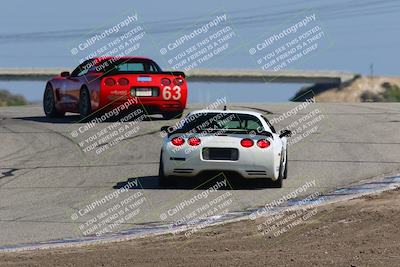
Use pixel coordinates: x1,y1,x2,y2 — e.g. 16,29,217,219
179,113,263,132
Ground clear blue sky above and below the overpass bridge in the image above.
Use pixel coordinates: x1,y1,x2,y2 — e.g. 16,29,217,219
0,0,400,102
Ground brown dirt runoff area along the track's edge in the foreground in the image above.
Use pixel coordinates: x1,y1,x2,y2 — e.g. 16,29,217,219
0,188,400,266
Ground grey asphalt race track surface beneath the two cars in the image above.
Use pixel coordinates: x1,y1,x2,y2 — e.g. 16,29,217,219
0,103,400,247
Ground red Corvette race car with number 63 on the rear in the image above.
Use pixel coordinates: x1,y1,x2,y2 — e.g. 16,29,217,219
43,57,187,119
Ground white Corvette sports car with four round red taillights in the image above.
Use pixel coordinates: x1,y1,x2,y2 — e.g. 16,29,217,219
159,110,291,187
